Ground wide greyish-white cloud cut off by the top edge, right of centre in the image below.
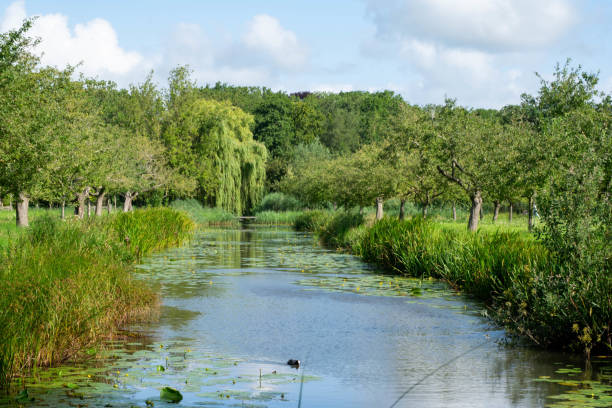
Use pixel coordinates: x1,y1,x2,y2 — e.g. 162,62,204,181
367,0,577,52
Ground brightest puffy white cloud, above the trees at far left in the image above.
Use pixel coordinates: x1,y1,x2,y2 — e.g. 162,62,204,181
0,1,144,78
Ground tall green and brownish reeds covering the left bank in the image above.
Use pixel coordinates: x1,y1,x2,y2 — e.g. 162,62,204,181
0,208,194,384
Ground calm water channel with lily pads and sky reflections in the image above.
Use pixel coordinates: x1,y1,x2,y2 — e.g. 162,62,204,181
5,228,612,407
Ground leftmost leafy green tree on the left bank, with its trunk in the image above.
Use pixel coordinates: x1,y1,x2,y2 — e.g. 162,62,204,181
0,21,79,226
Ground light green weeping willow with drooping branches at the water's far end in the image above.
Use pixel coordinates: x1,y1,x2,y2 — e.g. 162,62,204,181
165,99,267,214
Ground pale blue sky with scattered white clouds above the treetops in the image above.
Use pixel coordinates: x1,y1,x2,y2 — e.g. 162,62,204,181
0,0,612,108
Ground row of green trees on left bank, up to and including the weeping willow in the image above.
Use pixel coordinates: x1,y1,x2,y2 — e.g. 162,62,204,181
0,21,267,225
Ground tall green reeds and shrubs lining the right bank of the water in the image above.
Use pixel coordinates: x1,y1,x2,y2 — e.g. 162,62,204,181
296,211,612,353
